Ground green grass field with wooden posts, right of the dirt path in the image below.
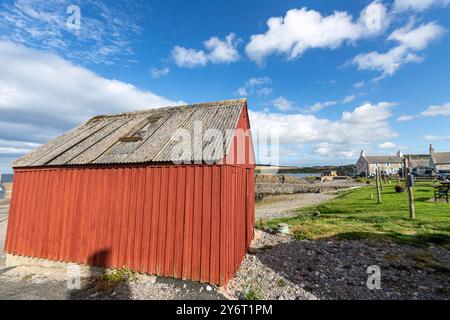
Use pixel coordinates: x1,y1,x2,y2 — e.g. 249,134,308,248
261,183,450,246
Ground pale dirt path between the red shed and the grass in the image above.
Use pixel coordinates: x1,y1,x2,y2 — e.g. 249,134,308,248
255,192,337,220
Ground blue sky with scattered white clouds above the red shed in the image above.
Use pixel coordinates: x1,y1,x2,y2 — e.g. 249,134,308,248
0,0,450,173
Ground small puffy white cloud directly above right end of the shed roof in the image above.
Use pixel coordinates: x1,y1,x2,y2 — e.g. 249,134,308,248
172,33,240,68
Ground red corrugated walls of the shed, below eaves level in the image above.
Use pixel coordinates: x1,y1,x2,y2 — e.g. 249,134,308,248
5,165,254,284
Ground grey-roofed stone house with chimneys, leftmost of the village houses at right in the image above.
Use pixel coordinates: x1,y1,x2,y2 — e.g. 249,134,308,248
356,151,403,177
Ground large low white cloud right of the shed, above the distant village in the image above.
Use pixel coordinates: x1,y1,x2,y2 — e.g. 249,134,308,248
250,102,396,161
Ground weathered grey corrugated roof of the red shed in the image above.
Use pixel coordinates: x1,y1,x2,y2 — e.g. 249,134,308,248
13,99,246,168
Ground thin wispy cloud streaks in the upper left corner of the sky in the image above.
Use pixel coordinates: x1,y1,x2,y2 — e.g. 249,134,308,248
0,0,141,64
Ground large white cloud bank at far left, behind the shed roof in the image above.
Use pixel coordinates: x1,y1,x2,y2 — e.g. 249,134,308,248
0,41,183,161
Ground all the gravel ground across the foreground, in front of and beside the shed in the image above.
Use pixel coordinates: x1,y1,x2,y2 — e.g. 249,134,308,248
0,231,450,300
